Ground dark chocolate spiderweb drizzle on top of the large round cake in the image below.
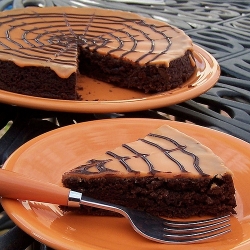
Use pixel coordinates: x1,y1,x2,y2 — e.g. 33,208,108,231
1,12,171,63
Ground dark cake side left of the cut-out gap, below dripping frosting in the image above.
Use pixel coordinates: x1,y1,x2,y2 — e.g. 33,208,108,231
0,61,77,100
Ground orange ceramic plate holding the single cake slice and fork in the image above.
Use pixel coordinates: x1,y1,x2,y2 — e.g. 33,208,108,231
2,118,250,250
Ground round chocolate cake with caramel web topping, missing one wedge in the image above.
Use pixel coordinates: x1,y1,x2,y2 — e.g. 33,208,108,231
0,7,196,100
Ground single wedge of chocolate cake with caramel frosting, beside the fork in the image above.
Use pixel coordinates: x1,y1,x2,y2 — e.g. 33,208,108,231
62,125,236,218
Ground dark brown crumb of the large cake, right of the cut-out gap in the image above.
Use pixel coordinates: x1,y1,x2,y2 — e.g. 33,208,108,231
79,49,196,93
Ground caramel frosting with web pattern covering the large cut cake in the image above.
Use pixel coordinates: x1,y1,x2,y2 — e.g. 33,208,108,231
0,7,193,78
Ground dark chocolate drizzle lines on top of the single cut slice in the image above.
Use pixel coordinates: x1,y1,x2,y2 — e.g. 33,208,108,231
73,129,209,177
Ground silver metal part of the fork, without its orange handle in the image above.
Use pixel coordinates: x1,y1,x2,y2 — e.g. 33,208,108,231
68,191,231,244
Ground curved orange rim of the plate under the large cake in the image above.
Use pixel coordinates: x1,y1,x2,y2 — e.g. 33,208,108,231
0,44,220,113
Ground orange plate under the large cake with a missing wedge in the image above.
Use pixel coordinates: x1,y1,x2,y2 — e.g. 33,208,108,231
0,45,220,113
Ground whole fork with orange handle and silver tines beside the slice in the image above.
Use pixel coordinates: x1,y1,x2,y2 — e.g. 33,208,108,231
0,169,230,244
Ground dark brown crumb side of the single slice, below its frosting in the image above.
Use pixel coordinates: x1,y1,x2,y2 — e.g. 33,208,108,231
61,175,236,218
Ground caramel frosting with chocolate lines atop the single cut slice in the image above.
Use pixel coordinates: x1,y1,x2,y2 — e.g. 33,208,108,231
65,125,230,178
